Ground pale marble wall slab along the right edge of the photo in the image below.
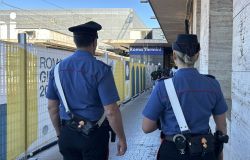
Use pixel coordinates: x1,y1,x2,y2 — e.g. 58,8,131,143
231,0,250,160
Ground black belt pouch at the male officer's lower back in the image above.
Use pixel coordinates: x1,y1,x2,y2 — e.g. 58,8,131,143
62,119,99,137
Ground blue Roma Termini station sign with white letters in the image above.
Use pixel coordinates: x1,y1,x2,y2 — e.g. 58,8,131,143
129,47,163,55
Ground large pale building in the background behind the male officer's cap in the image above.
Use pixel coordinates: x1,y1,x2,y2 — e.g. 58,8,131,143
0,8,147,40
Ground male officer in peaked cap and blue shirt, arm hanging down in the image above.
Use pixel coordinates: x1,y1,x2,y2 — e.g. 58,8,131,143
46,21,127,160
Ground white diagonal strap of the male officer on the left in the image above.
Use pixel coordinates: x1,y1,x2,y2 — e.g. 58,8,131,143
54,63,105,127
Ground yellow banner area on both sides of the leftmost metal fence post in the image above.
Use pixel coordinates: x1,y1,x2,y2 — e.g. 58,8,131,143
6,44,38,160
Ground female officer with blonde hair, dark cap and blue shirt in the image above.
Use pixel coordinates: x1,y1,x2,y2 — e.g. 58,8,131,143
142,34,228,160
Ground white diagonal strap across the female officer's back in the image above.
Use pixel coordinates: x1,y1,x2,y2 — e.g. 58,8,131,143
164,78,190,132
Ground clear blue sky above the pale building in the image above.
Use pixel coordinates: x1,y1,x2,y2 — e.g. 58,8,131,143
0,0,159,28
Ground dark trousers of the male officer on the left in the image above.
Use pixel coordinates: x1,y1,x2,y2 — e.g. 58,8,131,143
58,126,109,160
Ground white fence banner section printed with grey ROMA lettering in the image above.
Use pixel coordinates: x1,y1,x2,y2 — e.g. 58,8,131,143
34,47,71,150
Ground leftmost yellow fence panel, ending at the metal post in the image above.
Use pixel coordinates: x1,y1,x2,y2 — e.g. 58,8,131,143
6,45,25,159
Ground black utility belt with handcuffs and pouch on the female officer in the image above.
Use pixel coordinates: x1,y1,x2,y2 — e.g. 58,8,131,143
165,134,215,156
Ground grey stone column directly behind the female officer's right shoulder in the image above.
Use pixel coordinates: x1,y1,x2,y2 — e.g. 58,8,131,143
200,0,233,159
